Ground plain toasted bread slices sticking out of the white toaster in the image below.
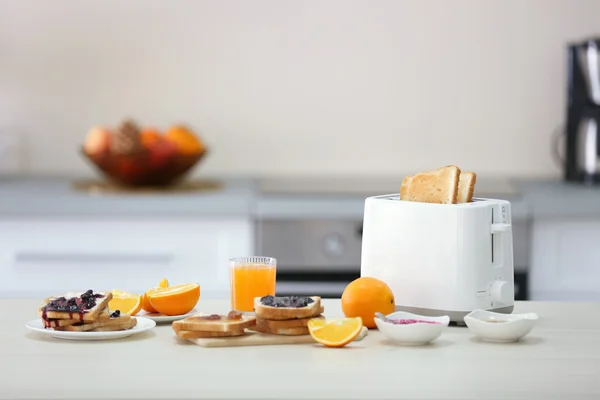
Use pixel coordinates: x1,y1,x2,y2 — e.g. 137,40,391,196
400,165,477,204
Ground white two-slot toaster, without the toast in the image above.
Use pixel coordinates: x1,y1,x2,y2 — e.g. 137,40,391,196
361,194,514,324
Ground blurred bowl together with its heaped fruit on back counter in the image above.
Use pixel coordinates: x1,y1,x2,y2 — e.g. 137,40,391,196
83,120,207,186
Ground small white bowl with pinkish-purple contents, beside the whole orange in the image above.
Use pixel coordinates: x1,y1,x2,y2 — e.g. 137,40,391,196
375,311,450,346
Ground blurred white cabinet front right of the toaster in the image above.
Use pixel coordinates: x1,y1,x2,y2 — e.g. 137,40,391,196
529,218,600,301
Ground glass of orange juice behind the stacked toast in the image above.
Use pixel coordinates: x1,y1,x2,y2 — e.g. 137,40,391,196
229,257,277,312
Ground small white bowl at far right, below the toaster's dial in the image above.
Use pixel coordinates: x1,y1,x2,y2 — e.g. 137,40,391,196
465,310,538,343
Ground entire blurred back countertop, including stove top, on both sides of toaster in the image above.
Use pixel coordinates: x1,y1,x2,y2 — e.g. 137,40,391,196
0,177,600,219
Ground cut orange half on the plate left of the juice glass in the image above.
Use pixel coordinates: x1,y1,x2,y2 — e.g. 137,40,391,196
146,283,200,315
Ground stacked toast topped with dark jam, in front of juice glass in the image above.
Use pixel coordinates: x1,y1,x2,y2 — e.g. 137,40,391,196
248,296,325,336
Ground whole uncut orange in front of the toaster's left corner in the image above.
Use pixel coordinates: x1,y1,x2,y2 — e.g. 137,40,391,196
342,277,396,328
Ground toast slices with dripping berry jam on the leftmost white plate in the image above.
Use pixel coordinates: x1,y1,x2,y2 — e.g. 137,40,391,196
38,289,137,332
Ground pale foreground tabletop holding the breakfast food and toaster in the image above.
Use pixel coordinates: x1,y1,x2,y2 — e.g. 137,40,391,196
0,299,600,400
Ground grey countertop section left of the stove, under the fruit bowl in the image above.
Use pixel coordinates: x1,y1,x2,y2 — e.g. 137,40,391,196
0,178,254,217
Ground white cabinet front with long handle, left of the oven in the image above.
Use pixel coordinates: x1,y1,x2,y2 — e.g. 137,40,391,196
0,217,254,298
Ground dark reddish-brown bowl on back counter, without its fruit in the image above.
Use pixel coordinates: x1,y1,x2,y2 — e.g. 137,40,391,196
82,149,207,187
